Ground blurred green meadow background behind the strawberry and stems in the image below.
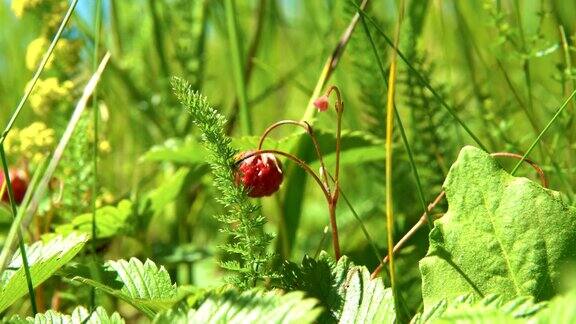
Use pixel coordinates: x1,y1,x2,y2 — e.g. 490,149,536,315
0,0,576,314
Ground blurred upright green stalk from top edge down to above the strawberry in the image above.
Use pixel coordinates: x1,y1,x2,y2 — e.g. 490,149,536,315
224,0,252,135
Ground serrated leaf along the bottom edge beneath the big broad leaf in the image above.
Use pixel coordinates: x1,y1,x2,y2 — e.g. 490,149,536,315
411,295,546,324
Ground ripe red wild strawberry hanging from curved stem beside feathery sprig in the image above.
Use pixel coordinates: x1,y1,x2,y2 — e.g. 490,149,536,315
236,152,284,198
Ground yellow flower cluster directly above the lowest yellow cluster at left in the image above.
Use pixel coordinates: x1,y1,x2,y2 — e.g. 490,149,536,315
27,77,74,116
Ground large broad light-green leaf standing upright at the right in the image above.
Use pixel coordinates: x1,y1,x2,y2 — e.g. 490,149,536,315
420,147,576,310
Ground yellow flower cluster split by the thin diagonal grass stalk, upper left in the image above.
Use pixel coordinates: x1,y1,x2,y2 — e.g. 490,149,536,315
26,36,81,73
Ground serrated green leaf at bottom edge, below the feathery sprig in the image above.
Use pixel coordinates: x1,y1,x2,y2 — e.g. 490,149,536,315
154,290,321,324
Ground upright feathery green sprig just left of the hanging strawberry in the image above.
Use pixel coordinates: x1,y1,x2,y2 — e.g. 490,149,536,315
172,78,272,287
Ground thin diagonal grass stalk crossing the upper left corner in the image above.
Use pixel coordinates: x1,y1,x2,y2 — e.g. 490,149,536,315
0,0,78,144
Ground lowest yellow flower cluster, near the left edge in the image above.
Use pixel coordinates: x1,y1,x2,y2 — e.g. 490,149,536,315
4,122,54,163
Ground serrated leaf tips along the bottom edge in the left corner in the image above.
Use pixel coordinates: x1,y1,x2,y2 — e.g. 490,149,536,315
6,306,124,324
